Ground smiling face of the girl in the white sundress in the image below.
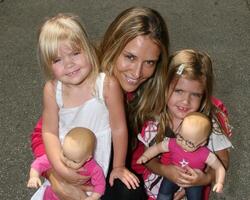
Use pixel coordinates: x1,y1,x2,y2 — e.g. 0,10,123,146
52,41,92,85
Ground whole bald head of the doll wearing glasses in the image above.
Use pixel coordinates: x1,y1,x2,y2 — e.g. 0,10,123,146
176,112,211,152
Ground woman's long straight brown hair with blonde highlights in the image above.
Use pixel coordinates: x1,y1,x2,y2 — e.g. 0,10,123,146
100,7,169,136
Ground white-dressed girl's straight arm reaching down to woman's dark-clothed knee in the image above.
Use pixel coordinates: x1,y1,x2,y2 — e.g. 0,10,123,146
104,76,139,189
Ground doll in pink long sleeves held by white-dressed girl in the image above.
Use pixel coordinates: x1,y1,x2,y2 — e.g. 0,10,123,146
27,127,105,200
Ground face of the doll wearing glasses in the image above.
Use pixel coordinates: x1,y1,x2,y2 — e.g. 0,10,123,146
176,121,207,152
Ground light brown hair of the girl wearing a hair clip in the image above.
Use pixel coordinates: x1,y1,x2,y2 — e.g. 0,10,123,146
157,49,214,141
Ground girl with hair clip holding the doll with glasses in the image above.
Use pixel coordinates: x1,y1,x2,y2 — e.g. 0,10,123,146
138,49,232,199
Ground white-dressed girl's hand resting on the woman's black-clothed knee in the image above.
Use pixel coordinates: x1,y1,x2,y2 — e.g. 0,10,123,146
109,167,140,189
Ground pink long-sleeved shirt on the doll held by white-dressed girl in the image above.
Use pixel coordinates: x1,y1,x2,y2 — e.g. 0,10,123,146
31,154,106,195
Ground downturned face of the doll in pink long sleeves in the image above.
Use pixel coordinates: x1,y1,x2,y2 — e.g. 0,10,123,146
61,141,92,169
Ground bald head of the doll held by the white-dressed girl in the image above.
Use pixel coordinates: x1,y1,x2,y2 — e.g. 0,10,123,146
61,127,96,169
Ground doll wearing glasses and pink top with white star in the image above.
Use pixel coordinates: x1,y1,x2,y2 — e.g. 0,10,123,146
137,112,225,200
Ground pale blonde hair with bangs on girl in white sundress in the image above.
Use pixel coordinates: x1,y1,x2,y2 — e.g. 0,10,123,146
38,13,99,79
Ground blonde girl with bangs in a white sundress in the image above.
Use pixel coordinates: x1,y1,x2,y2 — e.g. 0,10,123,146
30,14,138,199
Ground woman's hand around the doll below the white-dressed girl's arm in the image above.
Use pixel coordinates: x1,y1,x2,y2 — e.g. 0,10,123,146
47,170,93,200
